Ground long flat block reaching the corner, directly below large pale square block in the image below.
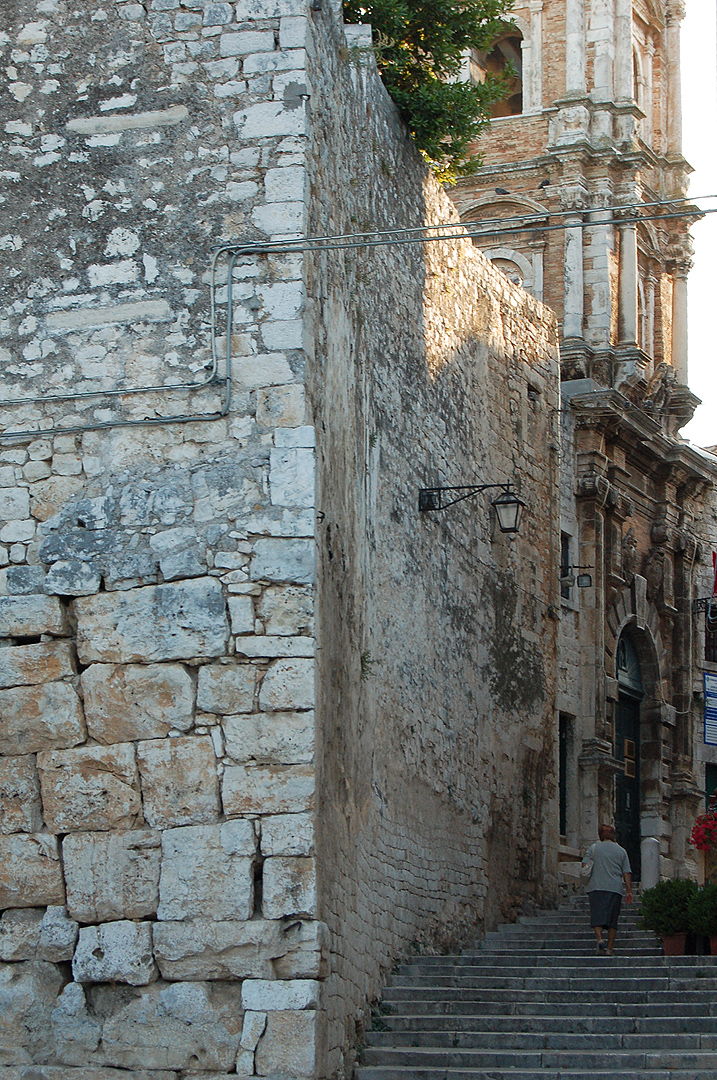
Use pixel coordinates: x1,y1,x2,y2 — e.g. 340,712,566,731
153,918,328,981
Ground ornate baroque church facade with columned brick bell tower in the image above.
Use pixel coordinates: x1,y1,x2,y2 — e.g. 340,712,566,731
451,0,716,882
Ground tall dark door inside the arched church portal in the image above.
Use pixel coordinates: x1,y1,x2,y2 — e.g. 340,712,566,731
614,634,645,881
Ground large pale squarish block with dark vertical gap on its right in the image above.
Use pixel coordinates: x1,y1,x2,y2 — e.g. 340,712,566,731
157,821,256,921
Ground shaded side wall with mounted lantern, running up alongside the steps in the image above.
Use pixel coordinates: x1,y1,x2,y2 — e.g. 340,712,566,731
307,8,559,1077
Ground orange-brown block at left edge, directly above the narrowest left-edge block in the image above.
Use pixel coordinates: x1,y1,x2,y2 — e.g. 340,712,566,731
0,683,86,754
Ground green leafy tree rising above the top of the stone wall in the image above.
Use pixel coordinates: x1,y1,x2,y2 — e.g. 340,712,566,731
343,0,513,183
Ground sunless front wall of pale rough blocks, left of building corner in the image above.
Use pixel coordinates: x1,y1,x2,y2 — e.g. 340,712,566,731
0,0,326,1080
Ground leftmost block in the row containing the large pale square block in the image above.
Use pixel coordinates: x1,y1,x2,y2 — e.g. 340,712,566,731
0,833,65,908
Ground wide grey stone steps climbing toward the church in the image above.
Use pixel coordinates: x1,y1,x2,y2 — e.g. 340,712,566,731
355,896,717,1080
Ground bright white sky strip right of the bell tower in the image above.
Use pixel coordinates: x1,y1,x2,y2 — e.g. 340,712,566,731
681,0,717,446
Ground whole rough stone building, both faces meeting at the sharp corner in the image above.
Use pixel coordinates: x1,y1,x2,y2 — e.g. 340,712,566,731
0,0,557,1080
